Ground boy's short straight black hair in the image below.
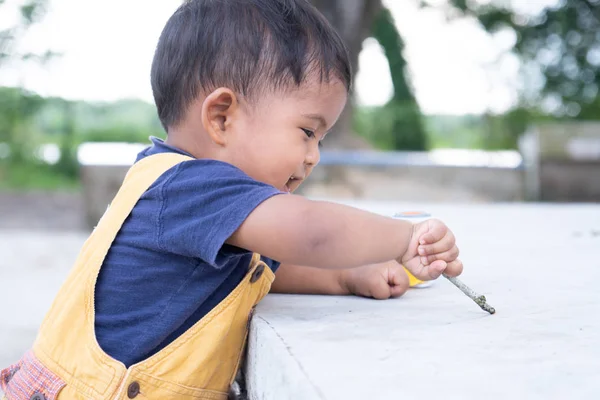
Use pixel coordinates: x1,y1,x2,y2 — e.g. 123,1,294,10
151,0,352,129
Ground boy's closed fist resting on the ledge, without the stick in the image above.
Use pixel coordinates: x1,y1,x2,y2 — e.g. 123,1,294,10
340,260,409,300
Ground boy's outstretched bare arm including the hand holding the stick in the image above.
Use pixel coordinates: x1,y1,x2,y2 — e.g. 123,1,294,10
227,195,462,280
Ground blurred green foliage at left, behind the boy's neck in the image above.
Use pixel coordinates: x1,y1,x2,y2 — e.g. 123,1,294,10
0,87,164,189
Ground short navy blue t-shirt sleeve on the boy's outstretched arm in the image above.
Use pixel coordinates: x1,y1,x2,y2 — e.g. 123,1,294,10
155,160,284,266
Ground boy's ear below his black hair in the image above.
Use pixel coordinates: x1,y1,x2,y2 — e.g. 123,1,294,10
202,88,239,146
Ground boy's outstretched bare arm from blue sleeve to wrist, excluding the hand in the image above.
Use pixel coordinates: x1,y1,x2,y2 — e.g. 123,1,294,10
228,195,413,269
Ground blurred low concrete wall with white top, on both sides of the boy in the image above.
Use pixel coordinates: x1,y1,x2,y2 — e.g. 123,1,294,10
78,143,525,227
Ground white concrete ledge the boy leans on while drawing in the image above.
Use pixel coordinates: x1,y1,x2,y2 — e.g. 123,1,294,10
246,203,600,400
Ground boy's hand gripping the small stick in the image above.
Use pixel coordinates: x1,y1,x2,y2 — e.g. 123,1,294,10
399,219,463,281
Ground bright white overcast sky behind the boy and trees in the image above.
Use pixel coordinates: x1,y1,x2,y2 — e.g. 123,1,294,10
0,0,552,115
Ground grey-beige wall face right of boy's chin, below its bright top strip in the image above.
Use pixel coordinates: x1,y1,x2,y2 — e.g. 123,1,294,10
299,165,525,202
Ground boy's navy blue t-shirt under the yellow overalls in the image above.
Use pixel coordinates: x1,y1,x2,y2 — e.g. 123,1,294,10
95,138,282,366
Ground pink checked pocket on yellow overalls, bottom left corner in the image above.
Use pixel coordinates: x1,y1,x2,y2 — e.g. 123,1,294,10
0,352,65,400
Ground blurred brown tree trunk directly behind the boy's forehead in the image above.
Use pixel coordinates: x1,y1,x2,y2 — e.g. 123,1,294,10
311,0,381,149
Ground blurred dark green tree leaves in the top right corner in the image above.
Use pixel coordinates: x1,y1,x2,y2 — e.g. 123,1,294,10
436,0,600,119
